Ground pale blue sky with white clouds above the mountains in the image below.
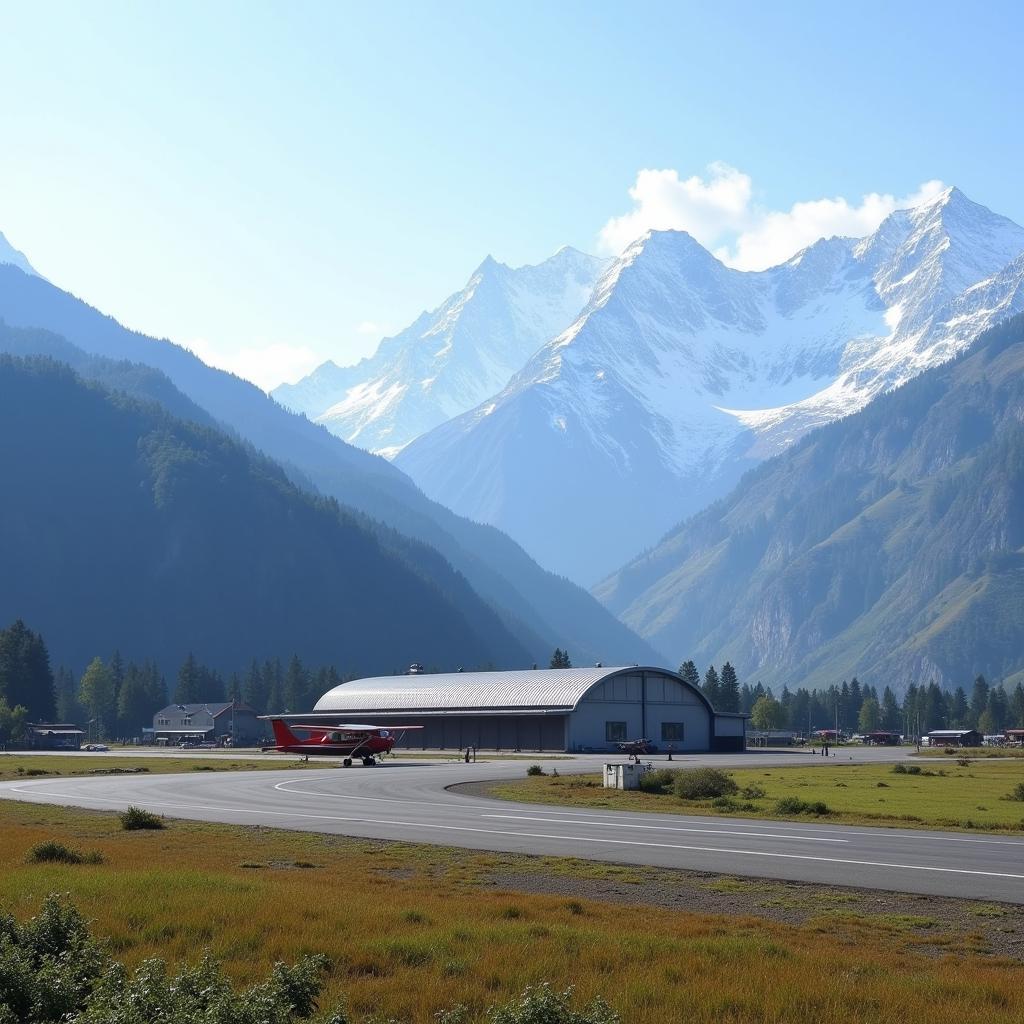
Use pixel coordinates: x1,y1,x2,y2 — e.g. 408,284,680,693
0,0,1024,388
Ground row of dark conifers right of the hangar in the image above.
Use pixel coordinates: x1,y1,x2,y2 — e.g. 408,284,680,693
679,662,1024,736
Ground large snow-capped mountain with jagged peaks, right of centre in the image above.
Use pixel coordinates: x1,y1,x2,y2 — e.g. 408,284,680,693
395,188,1024,584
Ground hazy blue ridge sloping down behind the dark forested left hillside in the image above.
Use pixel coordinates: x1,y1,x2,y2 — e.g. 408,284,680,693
0,265,660,664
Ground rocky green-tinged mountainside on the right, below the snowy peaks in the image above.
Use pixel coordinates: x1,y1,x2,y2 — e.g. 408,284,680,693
598,315,1024,688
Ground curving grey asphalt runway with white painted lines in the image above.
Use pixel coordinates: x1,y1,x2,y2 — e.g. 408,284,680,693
0,752,1024,903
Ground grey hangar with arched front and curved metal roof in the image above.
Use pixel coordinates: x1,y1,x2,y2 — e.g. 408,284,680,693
309,666,748,753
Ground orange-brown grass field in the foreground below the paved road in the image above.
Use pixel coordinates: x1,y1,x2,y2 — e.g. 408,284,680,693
0,802,1024,1024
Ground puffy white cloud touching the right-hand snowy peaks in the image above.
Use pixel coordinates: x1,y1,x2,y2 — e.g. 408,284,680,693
600,163,944,270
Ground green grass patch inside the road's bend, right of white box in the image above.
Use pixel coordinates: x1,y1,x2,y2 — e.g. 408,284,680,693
488,760,1024,831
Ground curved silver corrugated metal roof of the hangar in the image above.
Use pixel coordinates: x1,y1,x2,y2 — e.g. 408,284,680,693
315,667,630,712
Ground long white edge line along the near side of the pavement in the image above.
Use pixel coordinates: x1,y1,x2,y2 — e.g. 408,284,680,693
11,786,1024,881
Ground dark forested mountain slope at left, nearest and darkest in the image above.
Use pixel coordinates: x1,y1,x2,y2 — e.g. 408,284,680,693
0,356,532,674
